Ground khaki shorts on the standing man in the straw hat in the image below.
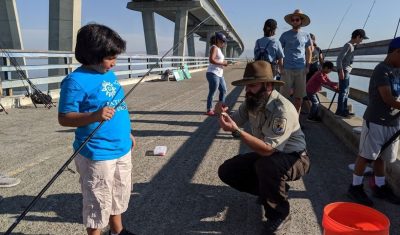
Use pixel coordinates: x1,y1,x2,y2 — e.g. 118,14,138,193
280,69,307,99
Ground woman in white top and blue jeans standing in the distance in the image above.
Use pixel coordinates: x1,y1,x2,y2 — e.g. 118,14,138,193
206,32,228,116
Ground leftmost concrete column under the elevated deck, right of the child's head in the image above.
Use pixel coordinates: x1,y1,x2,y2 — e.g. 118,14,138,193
142,11,158,55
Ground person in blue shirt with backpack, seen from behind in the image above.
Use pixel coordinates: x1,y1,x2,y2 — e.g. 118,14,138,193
254,19,285,76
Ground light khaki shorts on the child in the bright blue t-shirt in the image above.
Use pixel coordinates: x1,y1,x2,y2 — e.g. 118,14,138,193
75,151,132,229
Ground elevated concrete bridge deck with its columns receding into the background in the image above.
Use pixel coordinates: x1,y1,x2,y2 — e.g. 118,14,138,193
127,0,244,57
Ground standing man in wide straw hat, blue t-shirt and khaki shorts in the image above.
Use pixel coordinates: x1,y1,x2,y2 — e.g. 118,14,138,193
279,9,312,113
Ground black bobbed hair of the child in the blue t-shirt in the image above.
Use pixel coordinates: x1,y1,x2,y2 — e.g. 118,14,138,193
75,24,126,65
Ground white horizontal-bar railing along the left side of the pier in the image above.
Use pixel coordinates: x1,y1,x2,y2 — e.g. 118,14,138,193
0,50,244,96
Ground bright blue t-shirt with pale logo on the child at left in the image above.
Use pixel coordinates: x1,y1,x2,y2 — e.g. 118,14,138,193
58,67,132,161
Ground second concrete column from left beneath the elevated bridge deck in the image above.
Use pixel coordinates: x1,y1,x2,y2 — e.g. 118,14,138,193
174,9,188,56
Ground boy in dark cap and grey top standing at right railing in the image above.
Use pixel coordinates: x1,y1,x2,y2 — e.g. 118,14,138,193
335,29,368,118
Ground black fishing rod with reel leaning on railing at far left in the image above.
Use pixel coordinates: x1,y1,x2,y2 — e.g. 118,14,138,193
0,41,55,109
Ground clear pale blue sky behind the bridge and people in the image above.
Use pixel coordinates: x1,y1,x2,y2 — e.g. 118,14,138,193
16,0,400,57
